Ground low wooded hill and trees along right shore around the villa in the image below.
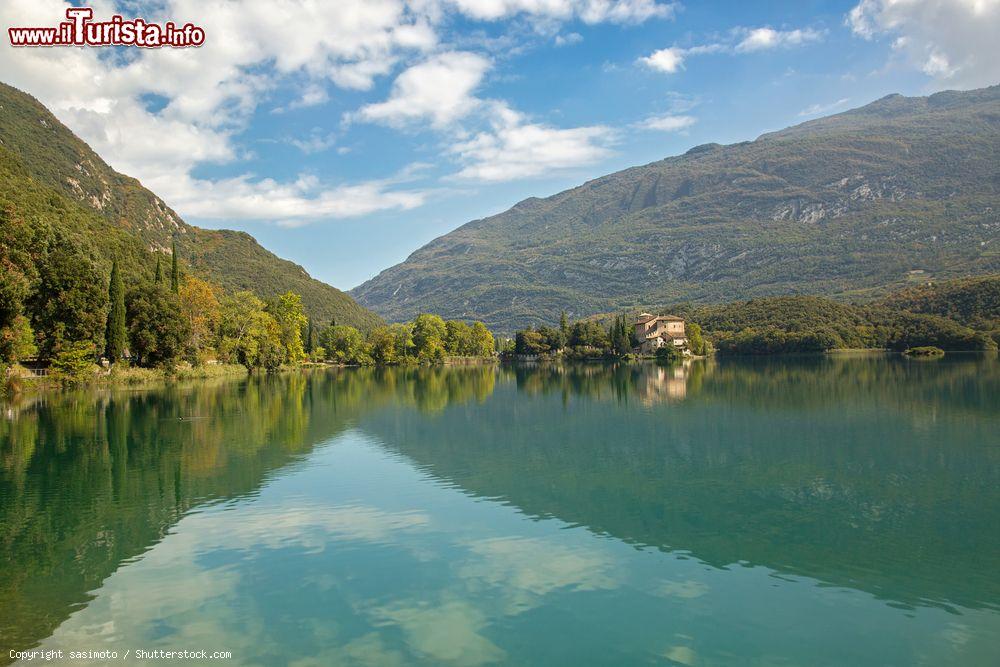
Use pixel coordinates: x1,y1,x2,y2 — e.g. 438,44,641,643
510,276,1000,358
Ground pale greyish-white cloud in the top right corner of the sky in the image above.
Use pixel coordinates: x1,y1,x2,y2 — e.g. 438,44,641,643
847,0,1000,88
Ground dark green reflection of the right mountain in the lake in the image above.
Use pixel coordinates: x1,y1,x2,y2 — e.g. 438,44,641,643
362,358,1000,608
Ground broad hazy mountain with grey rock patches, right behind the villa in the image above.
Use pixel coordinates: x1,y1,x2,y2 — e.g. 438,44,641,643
352,86,1000,331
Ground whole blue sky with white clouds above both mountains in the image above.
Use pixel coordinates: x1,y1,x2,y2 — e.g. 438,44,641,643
0,0,1000,289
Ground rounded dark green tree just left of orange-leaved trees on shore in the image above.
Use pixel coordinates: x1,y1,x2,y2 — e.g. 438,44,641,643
126,285,191,366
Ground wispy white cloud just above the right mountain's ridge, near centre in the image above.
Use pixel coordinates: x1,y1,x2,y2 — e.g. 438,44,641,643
450,102,615,182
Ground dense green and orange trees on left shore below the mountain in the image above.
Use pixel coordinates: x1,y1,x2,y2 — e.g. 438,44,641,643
0,206,307,380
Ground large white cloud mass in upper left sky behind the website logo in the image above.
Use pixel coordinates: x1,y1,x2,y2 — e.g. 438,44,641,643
0,0,437,224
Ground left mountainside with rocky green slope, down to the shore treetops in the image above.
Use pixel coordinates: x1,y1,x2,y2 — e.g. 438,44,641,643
0,84,380,330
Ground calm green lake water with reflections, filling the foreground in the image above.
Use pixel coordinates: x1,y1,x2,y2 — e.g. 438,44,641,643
0,356,1000,665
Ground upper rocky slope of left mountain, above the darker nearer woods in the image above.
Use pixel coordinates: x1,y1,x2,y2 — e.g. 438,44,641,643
0,84,380,329
